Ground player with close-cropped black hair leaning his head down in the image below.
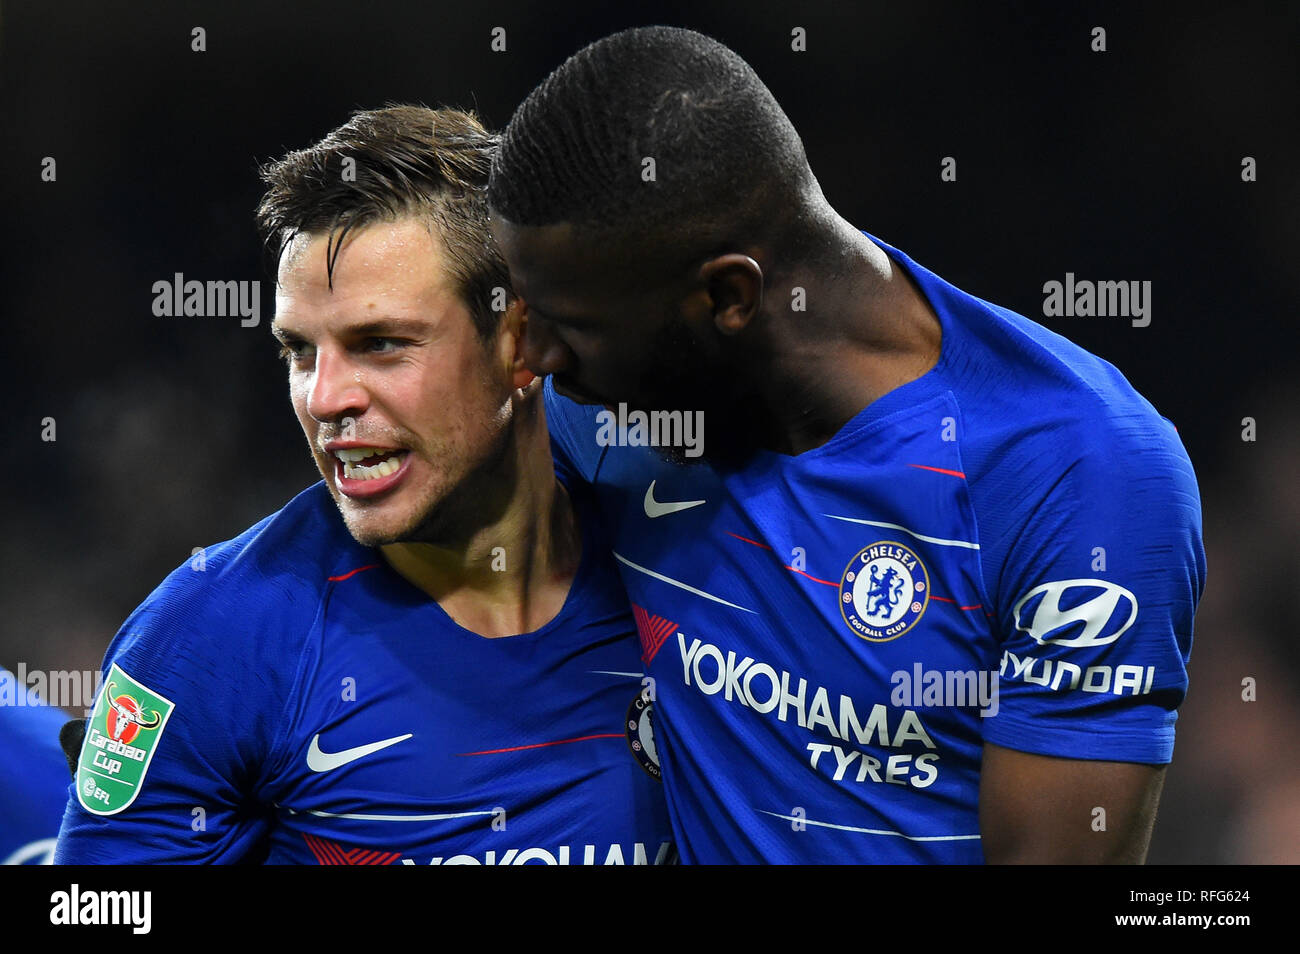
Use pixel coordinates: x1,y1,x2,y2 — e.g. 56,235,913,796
489,27,1205,863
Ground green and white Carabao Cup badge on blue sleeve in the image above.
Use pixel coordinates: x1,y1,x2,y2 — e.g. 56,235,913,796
77,663,176,815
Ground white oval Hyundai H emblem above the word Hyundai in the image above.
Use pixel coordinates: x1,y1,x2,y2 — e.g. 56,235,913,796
1014,580,1138,646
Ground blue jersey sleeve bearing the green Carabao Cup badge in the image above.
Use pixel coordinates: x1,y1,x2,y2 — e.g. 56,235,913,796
55,528,319,864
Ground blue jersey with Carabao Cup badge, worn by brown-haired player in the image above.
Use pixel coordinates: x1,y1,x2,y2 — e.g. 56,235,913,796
56,483,676,864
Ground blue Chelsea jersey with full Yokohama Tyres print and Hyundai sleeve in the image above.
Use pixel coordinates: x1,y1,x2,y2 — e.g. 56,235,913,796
546,233,1205,863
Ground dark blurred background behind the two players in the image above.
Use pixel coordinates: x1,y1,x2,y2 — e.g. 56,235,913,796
0,0,1300,863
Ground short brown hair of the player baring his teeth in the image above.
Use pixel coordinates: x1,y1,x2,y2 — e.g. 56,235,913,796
257,105,510,339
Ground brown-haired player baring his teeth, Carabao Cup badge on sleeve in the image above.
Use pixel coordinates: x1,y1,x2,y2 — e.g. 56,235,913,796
56,107,672,864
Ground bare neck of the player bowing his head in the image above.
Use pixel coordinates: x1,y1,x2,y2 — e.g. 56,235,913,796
750,216,941,454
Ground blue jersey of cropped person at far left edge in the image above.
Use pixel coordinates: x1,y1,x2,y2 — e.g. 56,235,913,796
0,669,72,864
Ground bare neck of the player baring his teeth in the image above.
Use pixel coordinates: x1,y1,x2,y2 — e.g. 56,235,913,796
381,390,582,638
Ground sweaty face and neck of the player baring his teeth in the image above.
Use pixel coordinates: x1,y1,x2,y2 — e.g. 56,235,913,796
273,218,581,637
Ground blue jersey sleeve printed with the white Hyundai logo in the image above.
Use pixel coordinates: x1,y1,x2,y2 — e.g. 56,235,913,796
976,406,1205,764
